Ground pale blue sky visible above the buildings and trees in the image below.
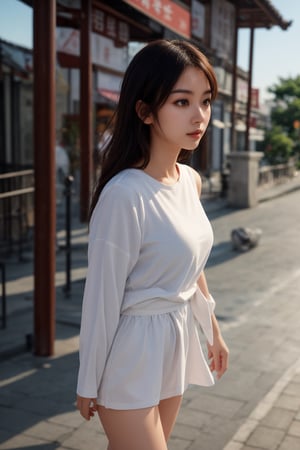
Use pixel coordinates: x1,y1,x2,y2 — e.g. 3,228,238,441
0,0,300,100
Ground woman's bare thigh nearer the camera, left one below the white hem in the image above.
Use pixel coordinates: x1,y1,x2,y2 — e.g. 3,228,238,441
98,405,167,450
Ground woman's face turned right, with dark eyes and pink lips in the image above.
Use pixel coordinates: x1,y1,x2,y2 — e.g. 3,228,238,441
145,67,212,152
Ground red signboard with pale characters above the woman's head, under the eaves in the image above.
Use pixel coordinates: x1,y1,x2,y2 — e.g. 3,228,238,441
125,0,191,38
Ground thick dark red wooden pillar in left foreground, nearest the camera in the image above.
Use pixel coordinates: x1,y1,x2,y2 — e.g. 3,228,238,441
33,0,56,356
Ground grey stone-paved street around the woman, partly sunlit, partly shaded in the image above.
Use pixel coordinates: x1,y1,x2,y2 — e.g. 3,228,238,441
0,173,300,450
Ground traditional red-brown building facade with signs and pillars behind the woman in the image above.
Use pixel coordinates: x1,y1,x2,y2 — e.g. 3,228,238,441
0,0,290,356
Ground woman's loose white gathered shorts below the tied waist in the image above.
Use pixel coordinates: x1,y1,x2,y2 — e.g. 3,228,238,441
97,301,214,409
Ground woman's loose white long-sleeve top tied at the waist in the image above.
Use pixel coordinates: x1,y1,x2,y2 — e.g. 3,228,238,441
77,164,214,398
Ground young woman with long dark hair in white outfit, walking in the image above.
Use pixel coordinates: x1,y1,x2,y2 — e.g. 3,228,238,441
77,40,228,450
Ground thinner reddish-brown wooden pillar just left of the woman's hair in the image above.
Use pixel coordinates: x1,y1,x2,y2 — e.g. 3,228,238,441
80,0,93,222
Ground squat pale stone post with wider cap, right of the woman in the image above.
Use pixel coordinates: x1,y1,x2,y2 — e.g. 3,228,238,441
227,151,263,208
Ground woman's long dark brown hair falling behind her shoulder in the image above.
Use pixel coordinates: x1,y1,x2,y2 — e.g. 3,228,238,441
90,40,217,215
